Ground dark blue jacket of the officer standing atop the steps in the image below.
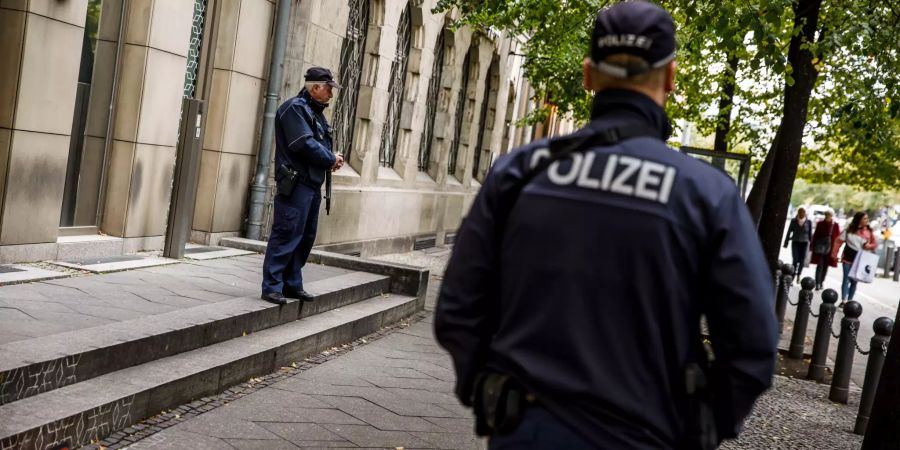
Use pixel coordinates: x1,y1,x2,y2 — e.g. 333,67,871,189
275,89,336,189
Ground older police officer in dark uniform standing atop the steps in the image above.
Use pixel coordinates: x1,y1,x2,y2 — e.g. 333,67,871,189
262,67,344,304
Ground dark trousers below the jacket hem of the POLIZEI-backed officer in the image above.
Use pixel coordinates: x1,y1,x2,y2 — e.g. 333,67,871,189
490,407,596,450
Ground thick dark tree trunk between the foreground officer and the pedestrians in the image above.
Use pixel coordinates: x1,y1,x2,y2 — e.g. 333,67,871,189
759,0,823,268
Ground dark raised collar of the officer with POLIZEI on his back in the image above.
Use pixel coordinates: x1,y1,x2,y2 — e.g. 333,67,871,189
591,89,672,140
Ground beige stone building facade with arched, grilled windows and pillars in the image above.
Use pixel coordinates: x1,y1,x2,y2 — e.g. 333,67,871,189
0,0,534,263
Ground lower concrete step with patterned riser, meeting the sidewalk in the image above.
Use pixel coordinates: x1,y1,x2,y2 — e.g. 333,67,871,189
0,294,419,449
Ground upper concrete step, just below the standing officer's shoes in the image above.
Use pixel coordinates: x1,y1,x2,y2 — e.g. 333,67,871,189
0,272,391,408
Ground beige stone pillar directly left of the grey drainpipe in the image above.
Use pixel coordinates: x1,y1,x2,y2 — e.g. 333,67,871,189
193,0,272,245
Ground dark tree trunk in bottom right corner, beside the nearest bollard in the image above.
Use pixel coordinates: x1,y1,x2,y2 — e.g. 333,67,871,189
862,311,900,450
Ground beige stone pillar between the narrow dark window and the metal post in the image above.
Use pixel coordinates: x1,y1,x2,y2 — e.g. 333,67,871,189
101,0,194,252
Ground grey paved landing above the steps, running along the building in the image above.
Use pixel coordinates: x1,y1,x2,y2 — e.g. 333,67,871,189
0,254,350,346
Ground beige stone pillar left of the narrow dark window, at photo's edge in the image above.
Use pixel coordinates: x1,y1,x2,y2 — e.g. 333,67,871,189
0,0,87,262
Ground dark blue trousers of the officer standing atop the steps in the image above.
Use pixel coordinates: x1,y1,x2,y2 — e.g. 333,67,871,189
262,183,322,294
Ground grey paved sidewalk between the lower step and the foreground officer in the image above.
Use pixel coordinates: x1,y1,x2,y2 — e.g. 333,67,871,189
115,277,485,450
